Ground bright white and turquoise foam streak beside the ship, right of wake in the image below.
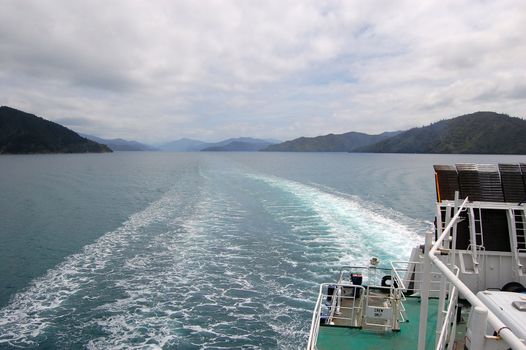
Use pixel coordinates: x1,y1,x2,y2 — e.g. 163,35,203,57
250,174,428,264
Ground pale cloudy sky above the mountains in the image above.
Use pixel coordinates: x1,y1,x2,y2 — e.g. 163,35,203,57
0,0,526,144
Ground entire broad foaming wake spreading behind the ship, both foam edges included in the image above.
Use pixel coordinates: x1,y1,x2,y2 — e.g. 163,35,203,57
0,168,432,349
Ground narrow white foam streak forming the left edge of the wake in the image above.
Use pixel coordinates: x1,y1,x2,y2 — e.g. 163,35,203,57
0,195,179,346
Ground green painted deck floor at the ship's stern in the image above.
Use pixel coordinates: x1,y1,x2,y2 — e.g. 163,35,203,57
316,297,438,350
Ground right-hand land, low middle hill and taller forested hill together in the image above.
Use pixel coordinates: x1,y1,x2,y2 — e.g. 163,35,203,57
264,112,526,154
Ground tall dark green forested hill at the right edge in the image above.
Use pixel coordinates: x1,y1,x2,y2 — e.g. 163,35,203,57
357,112,526,154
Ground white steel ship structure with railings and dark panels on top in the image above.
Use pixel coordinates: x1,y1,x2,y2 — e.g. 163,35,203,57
307,164,526,350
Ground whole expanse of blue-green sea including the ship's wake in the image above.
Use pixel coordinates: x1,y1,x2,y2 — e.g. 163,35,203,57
0,153,526,349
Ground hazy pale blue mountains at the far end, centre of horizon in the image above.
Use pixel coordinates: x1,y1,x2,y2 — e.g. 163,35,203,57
159,137,279,152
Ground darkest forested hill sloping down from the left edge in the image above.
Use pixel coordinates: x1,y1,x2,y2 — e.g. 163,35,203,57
0,106,111,154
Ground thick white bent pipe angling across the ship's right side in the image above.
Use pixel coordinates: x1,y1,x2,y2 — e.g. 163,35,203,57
428,197,526,350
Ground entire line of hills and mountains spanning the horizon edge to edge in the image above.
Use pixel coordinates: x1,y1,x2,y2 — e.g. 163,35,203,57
0,106,526,154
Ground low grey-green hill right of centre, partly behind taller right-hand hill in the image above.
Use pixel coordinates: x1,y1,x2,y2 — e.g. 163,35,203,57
264,131,398,152
